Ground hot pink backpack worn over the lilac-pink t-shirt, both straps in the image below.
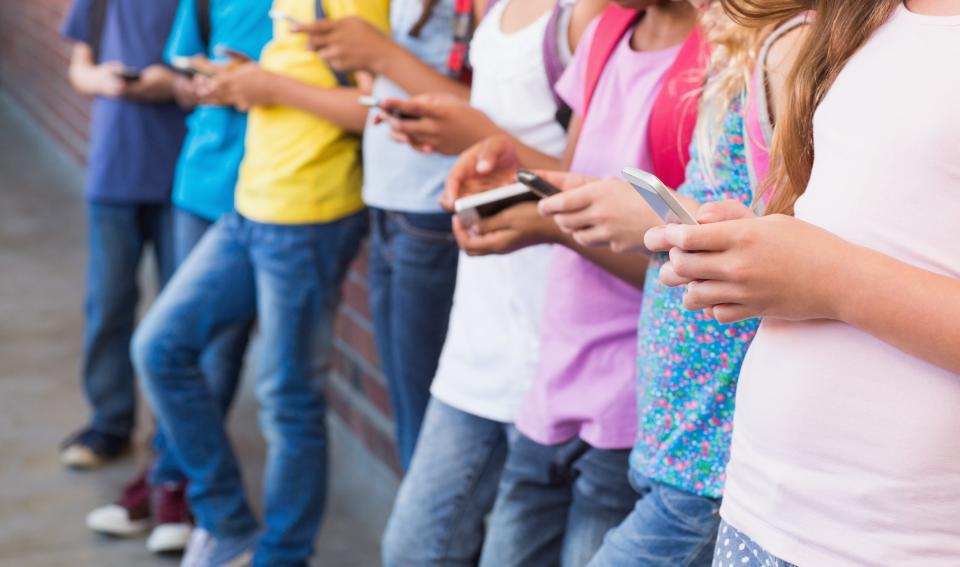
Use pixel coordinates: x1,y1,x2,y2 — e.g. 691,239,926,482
582,4,709,188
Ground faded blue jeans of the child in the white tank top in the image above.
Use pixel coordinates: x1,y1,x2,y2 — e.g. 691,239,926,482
383,398,516,567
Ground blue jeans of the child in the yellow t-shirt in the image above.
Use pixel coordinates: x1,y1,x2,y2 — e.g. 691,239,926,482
134,213,367,566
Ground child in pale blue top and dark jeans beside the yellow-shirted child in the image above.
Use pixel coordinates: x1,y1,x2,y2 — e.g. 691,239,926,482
298,0,471,469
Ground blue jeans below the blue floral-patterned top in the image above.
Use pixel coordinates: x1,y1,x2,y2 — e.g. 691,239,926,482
590,471,720,567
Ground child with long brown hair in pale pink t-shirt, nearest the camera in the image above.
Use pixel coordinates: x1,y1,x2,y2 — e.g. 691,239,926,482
647,0,960,566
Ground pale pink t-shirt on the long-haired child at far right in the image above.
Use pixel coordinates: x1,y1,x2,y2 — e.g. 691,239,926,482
722,6,960,567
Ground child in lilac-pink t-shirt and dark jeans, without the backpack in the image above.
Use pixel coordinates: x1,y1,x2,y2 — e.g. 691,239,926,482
452,2,696,565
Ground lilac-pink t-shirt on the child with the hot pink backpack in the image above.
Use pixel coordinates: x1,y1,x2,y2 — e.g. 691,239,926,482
517,23,679,449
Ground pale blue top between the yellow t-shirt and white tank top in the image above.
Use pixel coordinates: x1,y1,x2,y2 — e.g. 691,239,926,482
363,0,456,213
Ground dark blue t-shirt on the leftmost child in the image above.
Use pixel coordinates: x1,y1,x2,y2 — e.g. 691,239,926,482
61,0,186,203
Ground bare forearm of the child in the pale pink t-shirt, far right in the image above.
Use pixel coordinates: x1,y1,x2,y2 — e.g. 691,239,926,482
829,247,960,373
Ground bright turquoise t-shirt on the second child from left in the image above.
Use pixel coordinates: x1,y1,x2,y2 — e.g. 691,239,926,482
166,0,273,221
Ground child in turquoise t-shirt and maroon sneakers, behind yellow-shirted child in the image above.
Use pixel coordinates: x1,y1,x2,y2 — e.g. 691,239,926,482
86,0,272,553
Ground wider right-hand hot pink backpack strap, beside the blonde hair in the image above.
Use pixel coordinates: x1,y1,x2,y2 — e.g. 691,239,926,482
647,27,710,188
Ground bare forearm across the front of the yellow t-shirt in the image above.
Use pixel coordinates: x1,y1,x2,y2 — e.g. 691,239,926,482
274,75,367,133
